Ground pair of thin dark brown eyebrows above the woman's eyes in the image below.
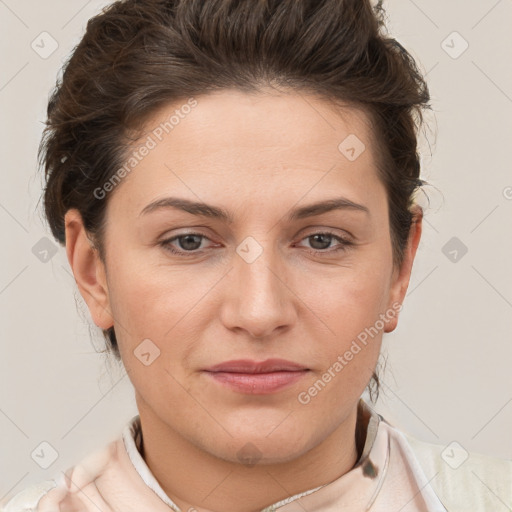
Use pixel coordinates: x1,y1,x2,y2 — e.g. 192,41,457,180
139,197,370,224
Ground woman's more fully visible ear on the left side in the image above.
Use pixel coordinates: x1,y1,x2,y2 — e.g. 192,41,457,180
64,209,114,329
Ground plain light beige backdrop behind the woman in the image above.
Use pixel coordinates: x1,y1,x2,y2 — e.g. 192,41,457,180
0,0,512,499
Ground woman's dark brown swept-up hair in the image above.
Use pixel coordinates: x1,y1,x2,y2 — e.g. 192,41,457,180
40,0,429,412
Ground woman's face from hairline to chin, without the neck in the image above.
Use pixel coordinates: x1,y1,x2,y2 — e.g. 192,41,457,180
68,91,415,462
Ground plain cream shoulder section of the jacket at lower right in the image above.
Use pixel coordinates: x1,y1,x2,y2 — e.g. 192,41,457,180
395,429,512,512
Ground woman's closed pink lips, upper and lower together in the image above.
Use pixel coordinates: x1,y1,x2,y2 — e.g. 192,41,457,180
205,359,309,395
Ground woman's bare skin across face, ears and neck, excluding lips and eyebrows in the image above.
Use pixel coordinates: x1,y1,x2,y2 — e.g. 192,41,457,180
65,91,422,512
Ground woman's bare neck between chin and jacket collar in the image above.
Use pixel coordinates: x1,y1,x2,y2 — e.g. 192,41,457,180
137,397,362,512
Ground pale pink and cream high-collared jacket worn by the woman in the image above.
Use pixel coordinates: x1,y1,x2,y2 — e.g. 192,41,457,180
0,400,512,512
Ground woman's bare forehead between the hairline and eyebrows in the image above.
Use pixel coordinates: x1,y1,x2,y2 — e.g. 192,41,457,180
110,90,382,214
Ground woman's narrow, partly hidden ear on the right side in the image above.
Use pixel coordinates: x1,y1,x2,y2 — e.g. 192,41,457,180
384,205,423,332
